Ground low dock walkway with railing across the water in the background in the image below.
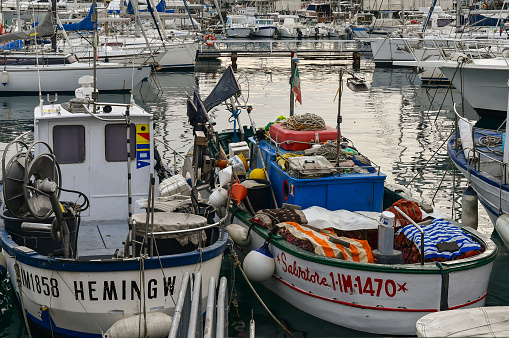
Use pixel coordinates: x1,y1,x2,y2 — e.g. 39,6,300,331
198,39,371,60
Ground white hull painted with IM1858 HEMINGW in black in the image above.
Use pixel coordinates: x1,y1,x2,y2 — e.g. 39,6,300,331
4,250,222,336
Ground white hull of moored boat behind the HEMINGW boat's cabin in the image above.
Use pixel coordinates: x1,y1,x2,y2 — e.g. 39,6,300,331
0,63,150,93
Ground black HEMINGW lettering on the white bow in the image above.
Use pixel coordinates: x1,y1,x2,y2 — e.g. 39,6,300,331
74,276,176,301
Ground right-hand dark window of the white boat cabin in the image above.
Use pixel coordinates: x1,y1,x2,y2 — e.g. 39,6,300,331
104,124,136,162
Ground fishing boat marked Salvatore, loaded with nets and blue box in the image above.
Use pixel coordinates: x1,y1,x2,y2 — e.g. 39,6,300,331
193,68,497,335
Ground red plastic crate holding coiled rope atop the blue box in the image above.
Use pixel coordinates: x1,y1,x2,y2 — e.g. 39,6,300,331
269,123,338,151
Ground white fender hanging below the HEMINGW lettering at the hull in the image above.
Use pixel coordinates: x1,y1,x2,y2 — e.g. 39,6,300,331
103,312,172,338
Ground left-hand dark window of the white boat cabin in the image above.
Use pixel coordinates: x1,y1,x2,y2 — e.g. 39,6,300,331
53,125,85,164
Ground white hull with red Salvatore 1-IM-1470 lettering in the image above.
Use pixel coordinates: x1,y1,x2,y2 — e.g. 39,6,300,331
233,220,496,335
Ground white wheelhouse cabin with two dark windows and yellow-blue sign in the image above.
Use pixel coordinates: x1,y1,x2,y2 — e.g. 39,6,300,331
34,98,157,219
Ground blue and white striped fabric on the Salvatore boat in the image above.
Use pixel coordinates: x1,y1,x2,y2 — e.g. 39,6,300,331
396,219,481,259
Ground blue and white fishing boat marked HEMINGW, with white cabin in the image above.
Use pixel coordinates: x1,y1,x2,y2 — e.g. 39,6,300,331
0,79,228,337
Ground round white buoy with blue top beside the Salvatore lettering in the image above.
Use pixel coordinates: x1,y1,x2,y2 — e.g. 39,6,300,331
243,243,276,282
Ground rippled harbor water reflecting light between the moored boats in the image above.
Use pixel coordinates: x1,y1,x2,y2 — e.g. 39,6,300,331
0,57,509,337
